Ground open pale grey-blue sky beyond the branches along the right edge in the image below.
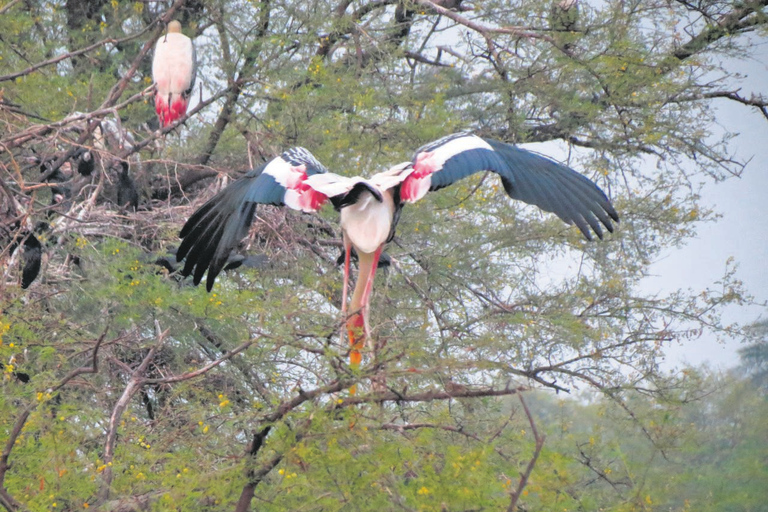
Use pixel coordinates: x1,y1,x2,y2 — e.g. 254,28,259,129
643,52,768,369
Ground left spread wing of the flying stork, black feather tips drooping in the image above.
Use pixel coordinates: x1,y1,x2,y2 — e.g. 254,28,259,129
176,148,327,291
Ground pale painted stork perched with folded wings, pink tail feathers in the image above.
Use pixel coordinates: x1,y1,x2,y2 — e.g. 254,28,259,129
152,20,197,127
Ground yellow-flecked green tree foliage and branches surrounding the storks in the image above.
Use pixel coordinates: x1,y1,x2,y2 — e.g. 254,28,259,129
0,0,768,512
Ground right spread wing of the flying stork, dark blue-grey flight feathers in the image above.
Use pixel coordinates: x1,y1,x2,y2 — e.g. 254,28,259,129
400,133,619,240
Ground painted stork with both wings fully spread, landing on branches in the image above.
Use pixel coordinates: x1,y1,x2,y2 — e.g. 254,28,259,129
176,133,619,367
